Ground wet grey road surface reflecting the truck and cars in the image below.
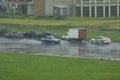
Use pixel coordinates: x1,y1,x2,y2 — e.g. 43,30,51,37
0,38,120,60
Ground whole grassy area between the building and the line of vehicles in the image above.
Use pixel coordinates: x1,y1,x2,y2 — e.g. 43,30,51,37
0,16,120,41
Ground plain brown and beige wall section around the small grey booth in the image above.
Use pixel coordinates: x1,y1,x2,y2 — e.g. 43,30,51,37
34,0,73,16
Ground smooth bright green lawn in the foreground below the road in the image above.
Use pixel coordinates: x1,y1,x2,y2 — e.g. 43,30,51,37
0,53,120,80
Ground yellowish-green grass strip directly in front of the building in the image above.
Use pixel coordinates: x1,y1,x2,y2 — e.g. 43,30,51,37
0,17,120,29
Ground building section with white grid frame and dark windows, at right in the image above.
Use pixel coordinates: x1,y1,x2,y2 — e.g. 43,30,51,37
74,0,120,17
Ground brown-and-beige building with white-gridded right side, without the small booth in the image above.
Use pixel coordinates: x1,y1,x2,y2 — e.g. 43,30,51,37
34,0,120,17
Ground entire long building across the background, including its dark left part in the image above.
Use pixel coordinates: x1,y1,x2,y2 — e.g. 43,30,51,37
7,0,120,17
